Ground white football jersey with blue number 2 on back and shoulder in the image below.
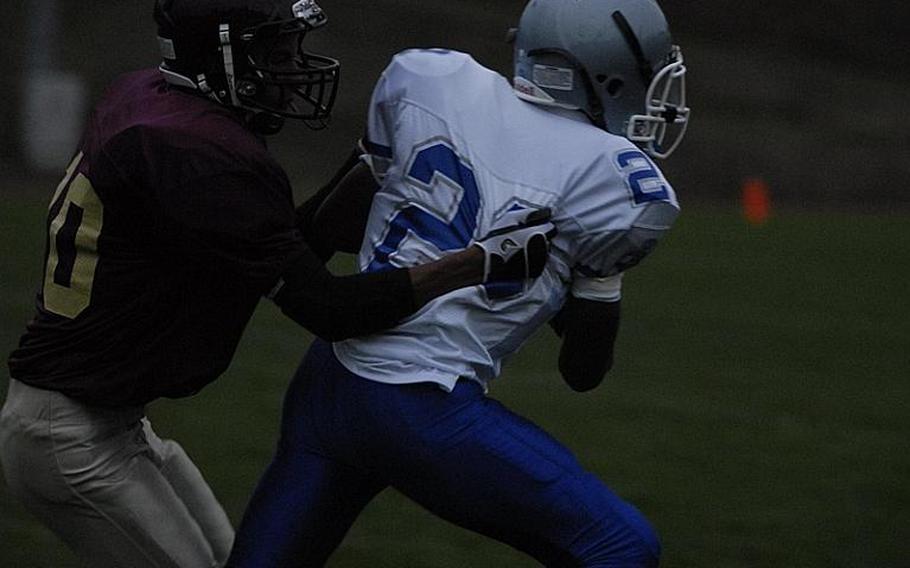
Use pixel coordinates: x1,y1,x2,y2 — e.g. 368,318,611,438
335,49,678,389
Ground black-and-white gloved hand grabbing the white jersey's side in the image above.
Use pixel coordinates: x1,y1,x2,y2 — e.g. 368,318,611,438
473,208,556,283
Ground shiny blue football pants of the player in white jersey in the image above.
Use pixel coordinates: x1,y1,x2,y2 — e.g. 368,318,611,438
228,340,660,568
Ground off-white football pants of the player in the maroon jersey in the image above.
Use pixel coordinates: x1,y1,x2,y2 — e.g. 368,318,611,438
2,389,224,567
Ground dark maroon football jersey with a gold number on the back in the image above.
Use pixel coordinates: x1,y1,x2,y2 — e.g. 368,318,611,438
9,70,305,406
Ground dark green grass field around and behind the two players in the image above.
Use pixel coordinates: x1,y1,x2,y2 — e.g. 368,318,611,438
0,189,910,568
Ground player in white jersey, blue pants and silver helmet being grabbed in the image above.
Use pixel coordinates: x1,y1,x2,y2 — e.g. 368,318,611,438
229,0,689,567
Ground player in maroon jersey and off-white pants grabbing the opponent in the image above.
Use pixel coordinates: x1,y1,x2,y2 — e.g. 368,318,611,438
0,0,548,568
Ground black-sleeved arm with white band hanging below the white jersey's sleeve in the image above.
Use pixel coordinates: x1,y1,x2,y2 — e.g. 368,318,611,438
550,274,622,392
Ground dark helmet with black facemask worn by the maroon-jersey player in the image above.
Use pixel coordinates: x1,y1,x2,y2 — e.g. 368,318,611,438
155,0,340,134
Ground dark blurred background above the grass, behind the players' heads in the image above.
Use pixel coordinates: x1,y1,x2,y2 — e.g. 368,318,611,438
0,0,910,211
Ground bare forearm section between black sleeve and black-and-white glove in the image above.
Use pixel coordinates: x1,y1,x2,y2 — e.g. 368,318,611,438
408,247,484,306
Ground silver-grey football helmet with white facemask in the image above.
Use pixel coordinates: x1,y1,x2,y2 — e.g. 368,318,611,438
512,0,689,158
